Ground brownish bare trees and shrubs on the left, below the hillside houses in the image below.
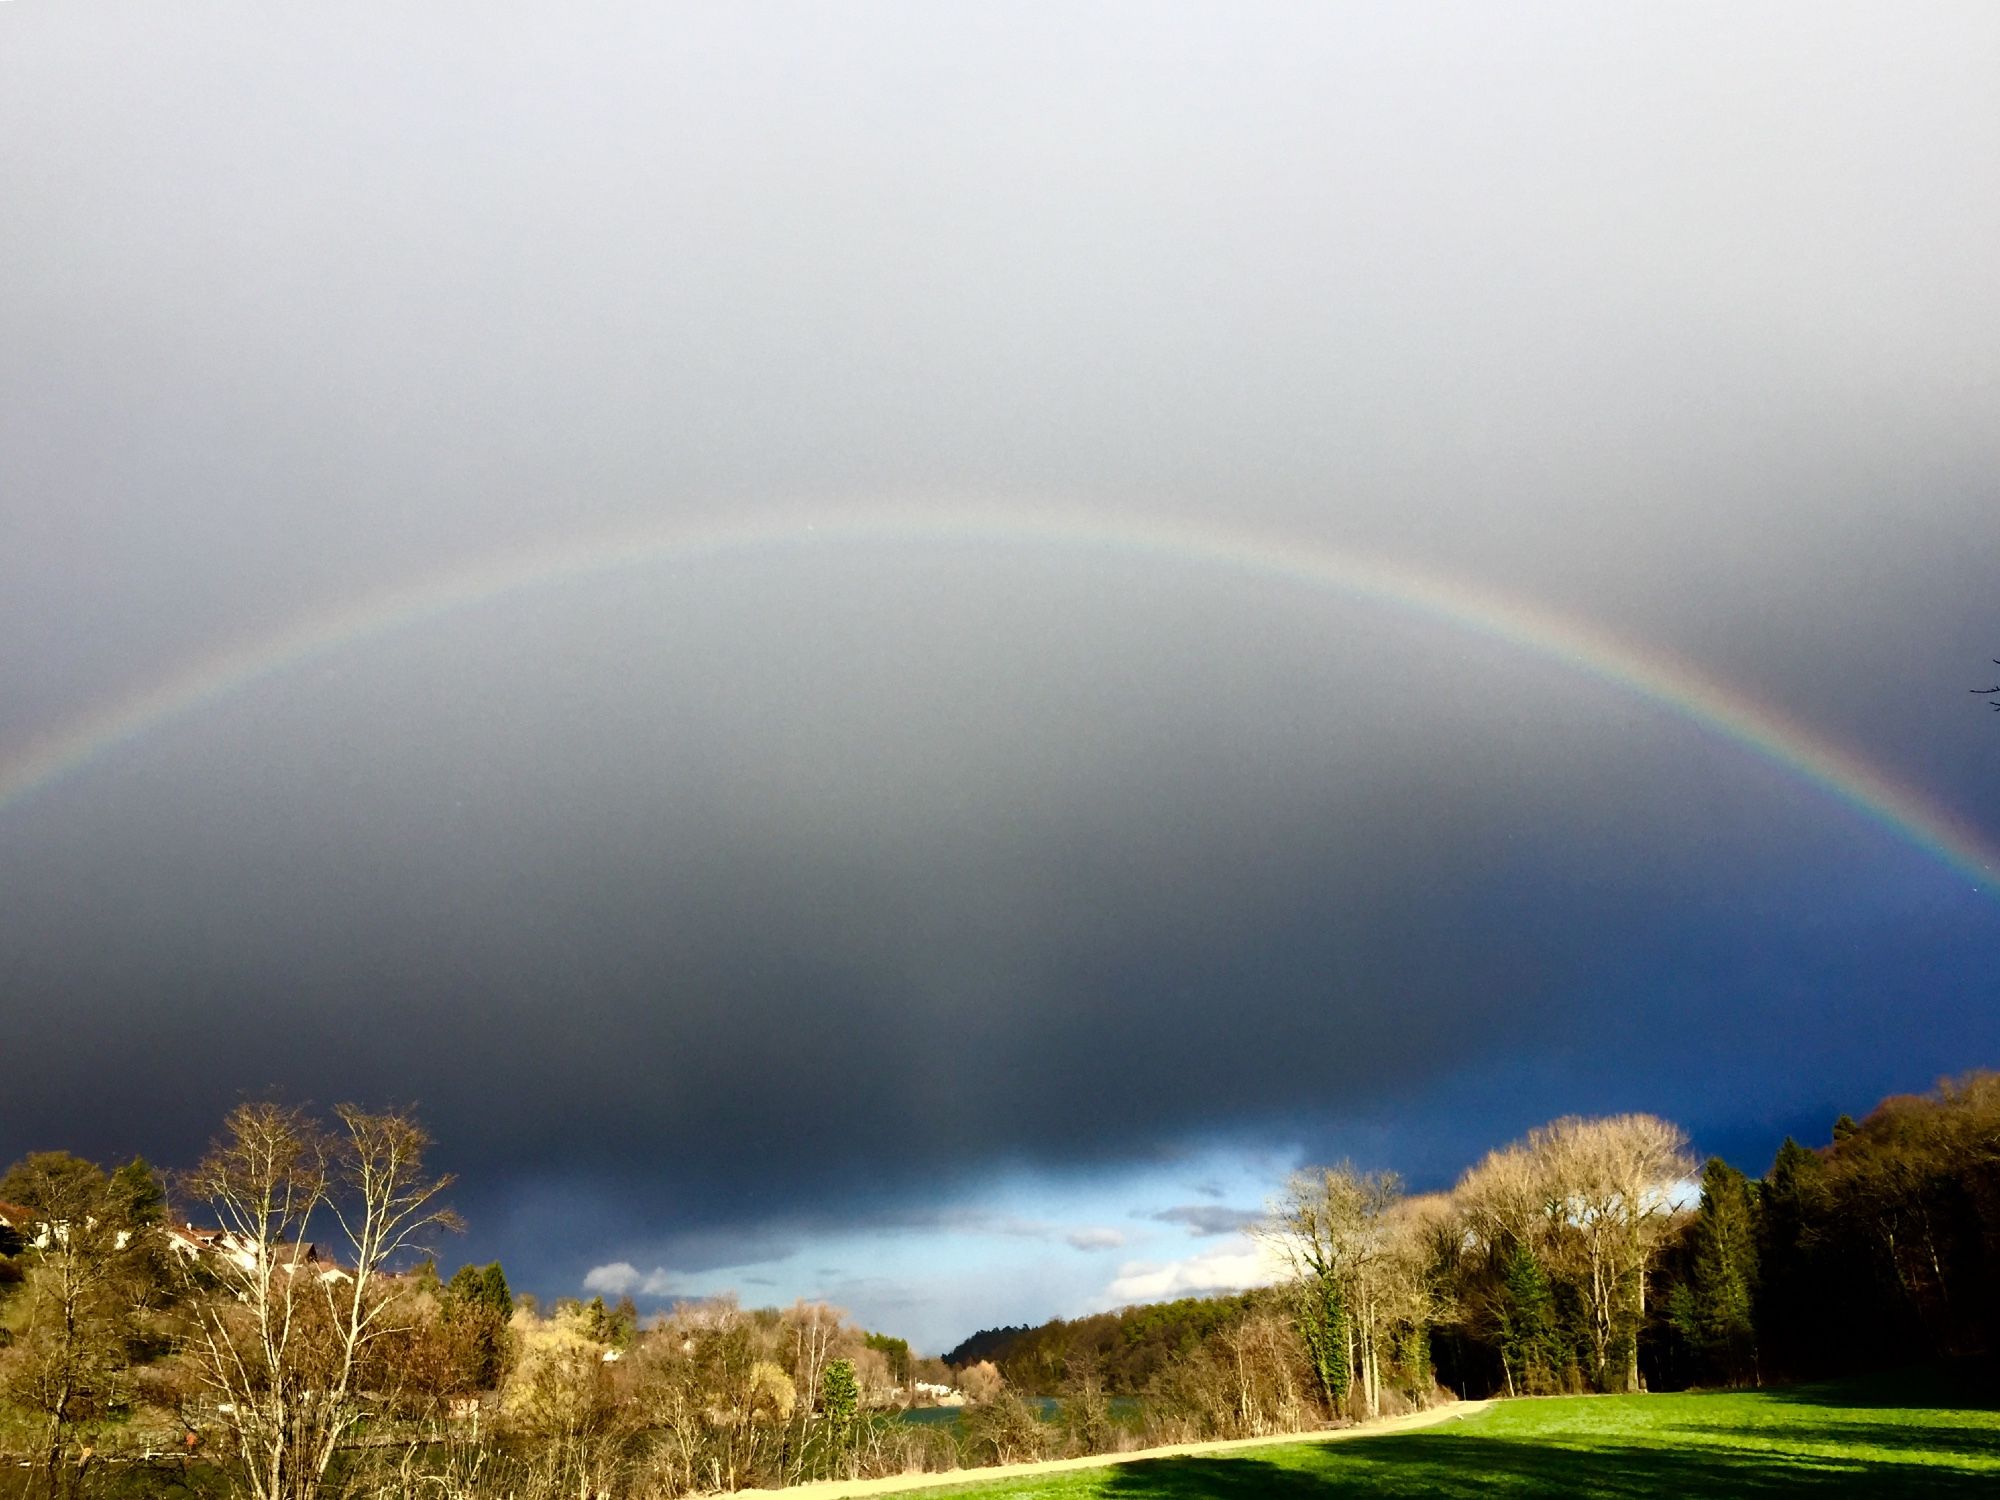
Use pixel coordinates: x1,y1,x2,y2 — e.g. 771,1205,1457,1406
0,1104,960,1500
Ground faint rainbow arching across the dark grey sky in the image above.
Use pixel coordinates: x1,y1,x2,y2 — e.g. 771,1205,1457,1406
0,508,2000,892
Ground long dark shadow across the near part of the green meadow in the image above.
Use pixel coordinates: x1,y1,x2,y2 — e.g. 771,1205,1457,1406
1102,1432,1996,1500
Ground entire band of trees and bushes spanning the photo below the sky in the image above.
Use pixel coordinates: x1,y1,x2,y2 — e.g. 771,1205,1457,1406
0,1072,2000,1500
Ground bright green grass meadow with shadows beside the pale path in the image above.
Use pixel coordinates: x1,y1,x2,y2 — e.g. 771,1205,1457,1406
922,1376,2000,1500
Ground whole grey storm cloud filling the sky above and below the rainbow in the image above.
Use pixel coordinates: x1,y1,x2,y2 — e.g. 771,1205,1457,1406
0,4,2000,1312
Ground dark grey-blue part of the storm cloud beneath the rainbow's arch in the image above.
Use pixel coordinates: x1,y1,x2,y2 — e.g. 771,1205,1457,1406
6,548,1978,1286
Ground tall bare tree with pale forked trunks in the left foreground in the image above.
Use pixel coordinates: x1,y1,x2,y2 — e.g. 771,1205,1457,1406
188,1104,458,1500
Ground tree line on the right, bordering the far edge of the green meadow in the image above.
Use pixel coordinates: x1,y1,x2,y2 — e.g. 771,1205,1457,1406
948,1072,2000,1436
